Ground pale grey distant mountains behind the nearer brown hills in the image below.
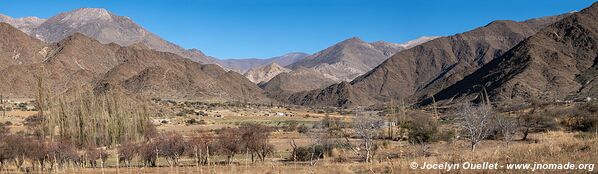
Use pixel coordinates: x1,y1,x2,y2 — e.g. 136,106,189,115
0,8,433,103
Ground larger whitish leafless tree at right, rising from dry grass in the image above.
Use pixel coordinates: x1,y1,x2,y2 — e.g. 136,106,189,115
457,103,494,151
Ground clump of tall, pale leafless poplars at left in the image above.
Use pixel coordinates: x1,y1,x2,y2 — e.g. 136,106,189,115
39,89,150,148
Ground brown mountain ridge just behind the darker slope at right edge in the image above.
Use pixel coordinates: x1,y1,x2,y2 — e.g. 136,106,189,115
292,14,568,107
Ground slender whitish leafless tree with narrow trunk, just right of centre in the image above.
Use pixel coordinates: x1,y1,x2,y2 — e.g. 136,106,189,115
353,113,384,162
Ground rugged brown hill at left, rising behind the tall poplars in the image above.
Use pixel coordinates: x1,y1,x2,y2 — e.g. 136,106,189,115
0,24,269,102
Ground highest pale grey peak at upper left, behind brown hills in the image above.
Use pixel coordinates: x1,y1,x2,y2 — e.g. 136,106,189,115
0,8,215,63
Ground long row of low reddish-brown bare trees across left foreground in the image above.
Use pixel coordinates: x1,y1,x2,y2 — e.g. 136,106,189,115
0,124,274,171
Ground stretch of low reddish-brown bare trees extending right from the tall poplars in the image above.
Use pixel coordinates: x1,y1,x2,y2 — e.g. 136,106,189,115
119,124,274,167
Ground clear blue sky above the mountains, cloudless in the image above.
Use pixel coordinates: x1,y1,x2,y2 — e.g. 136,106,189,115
0,0,594,58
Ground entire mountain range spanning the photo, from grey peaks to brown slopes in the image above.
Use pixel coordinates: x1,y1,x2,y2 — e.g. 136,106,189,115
0,3,598,107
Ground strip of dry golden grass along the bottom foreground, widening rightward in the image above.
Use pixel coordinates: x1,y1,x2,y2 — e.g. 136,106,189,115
4,132,598,174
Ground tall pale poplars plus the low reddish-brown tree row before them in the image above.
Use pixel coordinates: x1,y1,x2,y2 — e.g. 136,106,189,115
0,78,282,173
